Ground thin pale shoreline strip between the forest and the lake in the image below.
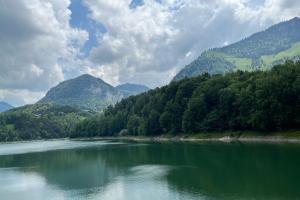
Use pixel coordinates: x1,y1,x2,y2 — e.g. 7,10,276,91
0,130,300,144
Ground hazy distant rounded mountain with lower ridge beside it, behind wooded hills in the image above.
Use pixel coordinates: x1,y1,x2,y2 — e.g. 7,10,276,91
38,74,149,110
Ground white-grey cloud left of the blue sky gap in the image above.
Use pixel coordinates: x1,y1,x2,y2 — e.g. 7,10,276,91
0,0,88,105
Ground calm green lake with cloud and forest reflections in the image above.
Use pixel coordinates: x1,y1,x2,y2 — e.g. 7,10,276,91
0,140,300,200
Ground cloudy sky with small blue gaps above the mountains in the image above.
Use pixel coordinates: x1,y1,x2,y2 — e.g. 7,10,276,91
0,0,300,106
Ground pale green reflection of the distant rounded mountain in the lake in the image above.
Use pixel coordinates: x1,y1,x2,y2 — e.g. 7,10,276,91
0,146,127,189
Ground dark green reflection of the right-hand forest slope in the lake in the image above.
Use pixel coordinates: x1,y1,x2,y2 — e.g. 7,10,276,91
97,143,300,199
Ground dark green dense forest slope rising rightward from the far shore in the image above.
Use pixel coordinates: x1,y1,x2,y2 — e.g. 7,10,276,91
72,61,300,137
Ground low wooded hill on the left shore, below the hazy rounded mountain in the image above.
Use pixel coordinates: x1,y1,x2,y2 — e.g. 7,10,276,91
0,104,92,141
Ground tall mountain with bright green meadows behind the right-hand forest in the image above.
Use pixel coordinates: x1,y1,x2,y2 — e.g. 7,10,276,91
173,17,300,81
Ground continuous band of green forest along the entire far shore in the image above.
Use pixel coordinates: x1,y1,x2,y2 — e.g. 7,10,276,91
0,61,300,141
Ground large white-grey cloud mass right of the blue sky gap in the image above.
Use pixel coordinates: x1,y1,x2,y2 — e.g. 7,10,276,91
84,0,300,87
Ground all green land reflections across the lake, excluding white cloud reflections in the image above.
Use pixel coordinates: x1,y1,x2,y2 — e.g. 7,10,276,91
0,143,300,199
